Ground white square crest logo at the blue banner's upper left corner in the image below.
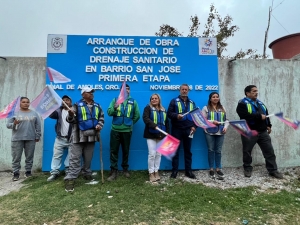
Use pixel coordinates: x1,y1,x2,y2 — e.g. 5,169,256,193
47,34,67,53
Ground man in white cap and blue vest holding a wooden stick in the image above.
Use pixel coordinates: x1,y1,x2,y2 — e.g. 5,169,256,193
65,87,104,191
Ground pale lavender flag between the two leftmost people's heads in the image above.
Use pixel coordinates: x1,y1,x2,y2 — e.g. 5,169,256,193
30,86,62,119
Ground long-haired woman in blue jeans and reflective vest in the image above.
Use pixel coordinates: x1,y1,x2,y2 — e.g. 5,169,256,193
202,92,229,179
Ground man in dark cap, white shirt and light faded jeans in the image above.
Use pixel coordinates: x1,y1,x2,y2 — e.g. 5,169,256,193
47,95,72,181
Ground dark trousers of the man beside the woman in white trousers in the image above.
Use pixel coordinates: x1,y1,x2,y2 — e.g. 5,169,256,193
172,128,192,171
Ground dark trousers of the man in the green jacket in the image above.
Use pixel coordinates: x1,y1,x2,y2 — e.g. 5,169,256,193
110,130,132,170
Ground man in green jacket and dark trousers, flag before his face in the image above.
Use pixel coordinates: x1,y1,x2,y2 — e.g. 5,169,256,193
107,84,140,181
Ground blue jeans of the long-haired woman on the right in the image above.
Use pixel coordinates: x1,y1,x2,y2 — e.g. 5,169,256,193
205,133,224,169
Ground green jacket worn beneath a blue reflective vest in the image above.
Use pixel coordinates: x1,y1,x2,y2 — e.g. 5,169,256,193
107,96,140,132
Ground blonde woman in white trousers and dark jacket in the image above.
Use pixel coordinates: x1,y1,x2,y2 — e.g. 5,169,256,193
143,94,169,182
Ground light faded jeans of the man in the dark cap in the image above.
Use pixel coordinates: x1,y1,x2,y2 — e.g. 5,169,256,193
50,137,70,174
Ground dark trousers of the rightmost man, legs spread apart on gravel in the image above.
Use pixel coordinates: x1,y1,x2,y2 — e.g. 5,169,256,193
241,131,277,172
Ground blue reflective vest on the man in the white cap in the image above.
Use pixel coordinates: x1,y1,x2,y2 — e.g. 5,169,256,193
76,101,101,130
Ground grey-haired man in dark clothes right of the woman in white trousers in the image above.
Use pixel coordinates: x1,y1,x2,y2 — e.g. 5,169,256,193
167,84,197,179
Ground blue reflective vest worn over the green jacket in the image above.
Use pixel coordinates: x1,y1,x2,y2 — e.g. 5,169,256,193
112,98,134,126
